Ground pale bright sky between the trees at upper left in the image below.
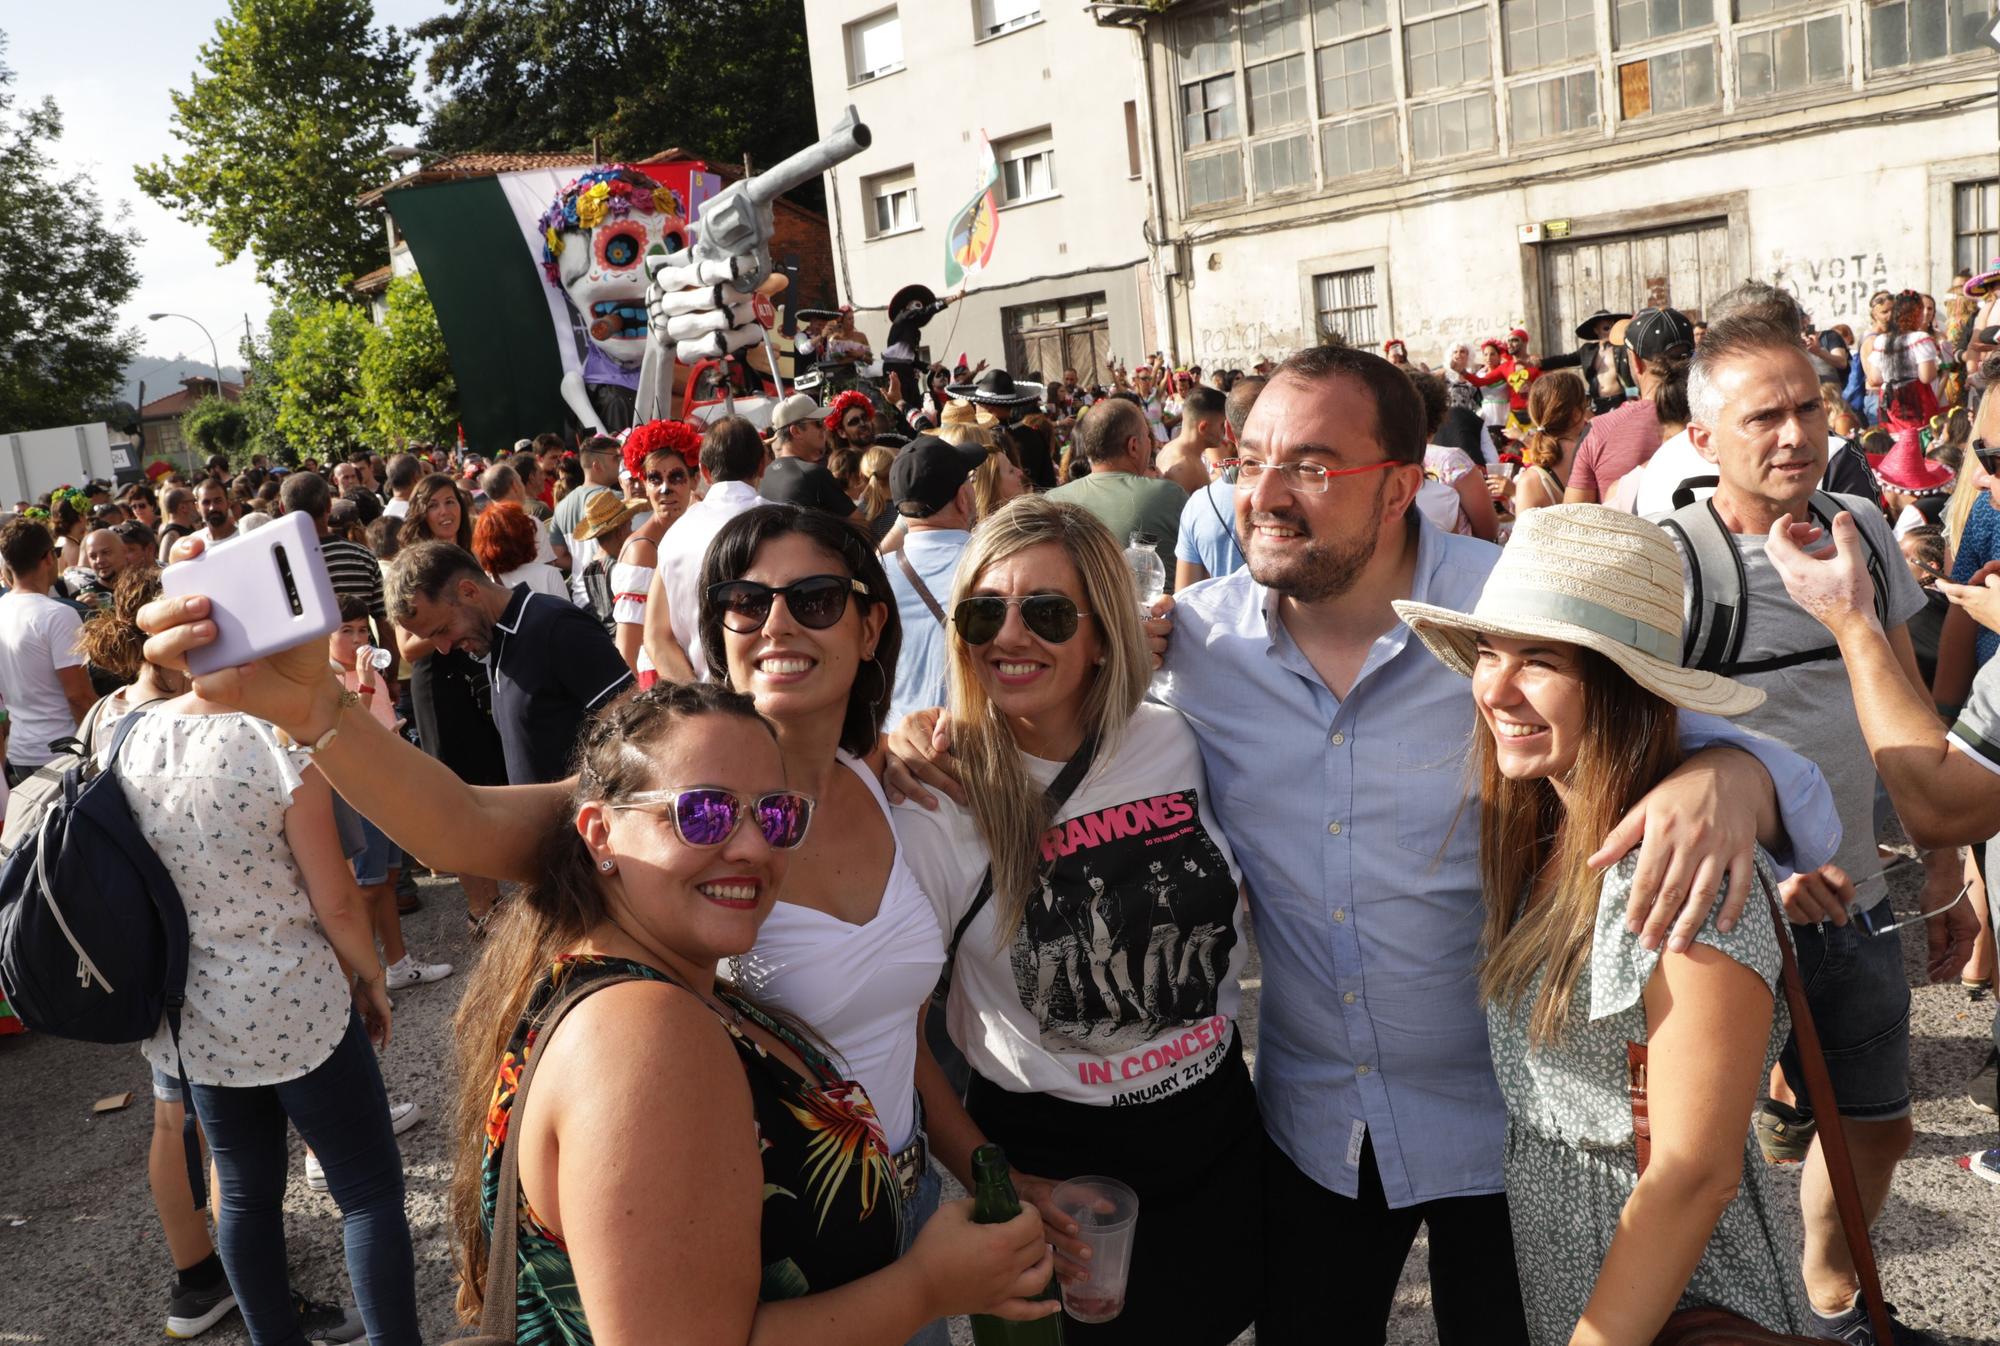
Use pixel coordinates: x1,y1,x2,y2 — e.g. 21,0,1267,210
0,0,446,384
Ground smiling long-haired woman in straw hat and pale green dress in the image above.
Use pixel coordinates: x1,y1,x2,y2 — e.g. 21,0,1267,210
1396,504,1808,1344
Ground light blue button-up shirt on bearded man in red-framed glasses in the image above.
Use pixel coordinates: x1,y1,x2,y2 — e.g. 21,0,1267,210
1154,524,1840,1206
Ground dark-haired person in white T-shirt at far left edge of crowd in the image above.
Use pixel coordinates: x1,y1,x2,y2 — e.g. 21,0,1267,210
0,518,98,786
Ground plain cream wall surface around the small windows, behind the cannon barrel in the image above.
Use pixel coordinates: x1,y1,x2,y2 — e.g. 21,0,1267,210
806,0,1152,364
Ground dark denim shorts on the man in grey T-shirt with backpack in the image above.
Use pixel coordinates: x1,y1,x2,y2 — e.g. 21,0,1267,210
1782,898,1910,1122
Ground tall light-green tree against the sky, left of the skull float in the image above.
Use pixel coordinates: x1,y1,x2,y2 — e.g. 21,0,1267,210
136,0,418,296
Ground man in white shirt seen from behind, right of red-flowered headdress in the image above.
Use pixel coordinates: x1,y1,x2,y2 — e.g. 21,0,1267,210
642,416,766,682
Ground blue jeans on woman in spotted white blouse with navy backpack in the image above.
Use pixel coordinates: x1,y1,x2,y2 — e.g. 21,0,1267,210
194,1012,422,1346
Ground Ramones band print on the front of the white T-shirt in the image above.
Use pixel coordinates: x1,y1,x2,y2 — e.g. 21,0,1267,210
1010,790,1236,1086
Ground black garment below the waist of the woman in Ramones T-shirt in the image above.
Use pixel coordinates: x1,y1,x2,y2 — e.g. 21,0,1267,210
966,1032,1264,1346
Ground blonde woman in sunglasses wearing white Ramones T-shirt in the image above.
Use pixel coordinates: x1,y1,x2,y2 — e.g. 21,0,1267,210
896,496,1264,1346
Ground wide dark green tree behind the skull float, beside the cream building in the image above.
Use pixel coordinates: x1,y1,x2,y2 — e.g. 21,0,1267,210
410,0,822,208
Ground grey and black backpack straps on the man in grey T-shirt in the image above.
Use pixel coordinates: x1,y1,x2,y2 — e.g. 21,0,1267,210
1660,476,1888,678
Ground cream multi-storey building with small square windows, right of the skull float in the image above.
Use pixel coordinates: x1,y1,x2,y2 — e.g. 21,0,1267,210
806,0,1162,380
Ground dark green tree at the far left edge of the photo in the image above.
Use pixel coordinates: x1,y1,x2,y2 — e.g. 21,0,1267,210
0,34,138,430
